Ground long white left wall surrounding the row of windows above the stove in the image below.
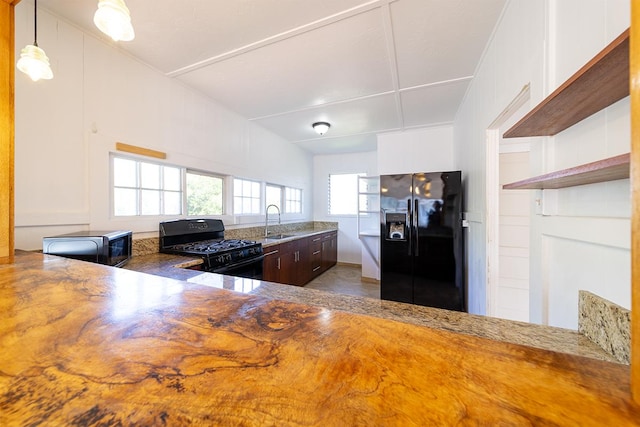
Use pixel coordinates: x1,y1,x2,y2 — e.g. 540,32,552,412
15,1,313,249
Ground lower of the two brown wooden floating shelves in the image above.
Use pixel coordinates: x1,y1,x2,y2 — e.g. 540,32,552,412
502,153,630,190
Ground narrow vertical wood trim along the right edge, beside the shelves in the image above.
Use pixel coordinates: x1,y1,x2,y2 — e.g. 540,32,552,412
629,0,640,404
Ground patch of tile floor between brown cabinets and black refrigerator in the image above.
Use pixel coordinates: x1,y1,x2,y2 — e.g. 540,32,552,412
305,265,380,299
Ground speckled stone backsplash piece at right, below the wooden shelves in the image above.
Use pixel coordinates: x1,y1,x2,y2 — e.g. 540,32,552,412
578,291,631,364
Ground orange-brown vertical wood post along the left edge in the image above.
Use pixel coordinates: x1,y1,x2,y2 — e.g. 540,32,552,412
0,0,20,264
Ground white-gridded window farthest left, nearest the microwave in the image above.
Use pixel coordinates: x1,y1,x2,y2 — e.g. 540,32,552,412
113,156,182,216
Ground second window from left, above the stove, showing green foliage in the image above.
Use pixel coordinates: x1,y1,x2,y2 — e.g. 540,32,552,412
186,171,224,216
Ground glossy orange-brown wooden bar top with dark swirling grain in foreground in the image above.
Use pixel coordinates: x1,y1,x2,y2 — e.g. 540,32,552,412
0,253,640,426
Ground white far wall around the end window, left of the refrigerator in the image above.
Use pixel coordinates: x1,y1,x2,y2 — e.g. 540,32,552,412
313,151,378,264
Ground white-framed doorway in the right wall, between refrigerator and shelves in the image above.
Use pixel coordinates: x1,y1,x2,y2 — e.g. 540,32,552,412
486,85,531,322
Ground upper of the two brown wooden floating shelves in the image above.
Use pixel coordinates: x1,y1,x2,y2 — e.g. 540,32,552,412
504,30,629,138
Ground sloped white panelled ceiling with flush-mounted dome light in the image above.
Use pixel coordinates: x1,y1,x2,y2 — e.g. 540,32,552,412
38,0,506,154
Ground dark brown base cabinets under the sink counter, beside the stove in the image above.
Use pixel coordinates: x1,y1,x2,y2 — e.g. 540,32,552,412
262,231,338,286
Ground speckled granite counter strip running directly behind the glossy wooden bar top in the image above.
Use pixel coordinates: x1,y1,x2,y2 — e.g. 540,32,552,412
124,252,619,363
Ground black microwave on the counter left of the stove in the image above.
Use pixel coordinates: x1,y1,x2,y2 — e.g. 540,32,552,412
42,230,133,267
